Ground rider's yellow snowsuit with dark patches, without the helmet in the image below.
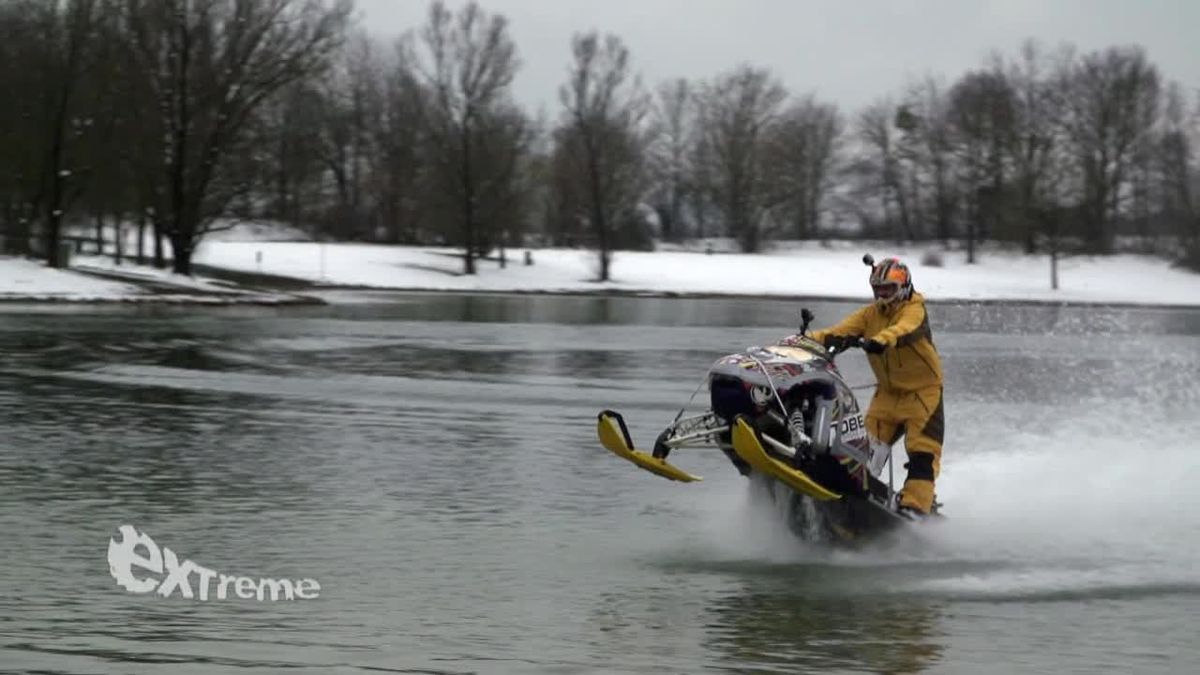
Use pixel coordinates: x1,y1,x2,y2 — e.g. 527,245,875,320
810,291,946,513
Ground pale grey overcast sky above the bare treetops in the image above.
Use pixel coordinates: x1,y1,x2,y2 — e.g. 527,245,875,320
358,0,1200,114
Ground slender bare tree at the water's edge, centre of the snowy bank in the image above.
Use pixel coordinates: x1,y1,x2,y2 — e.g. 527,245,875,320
558,31,649,281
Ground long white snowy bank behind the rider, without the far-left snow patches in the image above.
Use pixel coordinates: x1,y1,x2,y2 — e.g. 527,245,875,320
189,241,1200,306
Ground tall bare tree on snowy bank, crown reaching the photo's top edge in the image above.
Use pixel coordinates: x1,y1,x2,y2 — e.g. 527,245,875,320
418,0,518,274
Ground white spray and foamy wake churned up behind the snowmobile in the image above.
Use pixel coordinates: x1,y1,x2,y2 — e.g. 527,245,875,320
676,400,1200,601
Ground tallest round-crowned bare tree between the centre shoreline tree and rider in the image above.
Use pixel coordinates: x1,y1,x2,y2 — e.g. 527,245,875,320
697,66,787,253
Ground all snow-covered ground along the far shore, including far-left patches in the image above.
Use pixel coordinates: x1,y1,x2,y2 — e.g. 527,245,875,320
0,223,1200,306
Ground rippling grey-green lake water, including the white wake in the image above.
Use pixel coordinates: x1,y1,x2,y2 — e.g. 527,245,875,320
0,294,1200,674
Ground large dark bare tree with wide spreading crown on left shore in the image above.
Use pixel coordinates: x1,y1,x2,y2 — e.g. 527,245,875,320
124,0,352,274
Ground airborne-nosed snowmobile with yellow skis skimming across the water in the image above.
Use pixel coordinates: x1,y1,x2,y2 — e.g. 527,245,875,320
598,309,942,542
